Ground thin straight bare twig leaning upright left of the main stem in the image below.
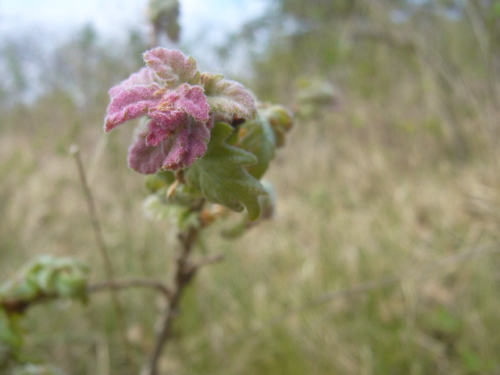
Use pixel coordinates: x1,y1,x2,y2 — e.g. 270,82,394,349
70,145,133,366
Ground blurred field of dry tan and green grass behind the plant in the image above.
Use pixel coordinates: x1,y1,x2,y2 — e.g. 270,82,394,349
0,95,500,374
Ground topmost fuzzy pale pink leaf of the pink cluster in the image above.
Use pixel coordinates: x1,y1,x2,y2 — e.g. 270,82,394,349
143,47,197,87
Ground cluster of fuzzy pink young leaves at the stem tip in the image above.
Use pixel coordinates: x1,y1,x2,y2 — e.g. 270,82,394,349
104,48,212,174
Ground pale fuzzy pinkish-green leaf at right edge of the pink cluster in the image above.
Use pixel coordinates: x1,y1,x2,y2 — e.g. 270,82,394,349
201,73,257,119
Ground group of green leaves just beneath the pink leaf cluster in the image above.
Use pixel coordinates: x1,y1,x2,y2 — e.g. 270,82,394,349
143,103,292,229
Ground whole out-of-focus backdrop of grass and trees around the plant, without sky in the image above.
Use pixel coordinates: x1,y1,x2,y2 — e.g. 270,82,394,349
0,0,500,375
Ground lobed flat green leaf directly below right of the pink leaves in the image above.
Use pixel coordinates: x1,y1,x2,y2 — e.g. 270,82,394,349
185,123,267,220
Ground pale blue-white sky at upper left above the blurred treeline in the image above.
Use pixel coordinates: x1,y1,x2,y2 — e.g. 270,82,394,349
0,0,269,100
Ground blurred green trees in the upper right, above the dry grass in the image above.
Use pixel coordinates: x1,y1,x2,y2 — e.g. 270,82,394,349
226,0,500,159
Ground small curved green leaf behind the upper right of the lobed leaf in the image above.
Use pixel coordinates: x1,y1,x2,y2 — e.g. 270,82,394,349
238,118,276,179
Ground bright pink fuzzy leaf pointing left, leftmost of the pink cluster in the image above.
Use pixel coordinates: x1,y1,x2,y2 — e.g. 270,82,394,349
104,83,161,132
